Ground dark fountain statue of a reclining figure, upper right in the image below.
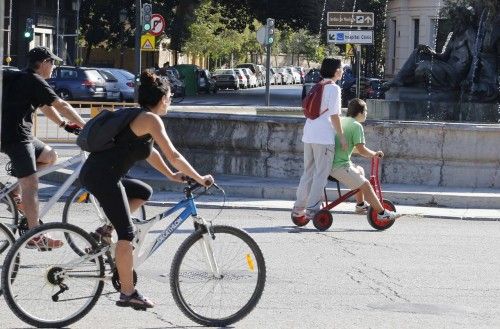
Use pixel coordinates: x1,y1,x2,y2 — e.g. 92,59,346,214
378,0,500,122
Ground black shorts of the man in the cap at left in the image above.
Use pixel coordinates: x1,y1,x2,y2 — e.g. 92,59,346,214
3,138,47,178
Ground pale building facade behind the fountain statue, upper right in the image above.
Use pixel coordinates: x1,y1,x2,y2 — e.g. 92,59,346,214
385,0,444,78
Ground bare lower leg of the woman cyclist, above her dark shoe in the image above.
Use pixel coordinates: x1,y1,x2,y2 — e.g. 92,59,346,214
116,240,135,295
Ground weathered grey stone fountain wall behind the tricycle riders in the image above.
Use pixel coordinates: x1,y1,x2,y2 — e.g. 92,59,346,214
164,112,500,188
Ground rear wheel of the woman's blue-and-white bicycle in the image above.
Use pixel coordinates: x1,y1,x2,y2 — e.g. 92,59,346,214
2,223,104,328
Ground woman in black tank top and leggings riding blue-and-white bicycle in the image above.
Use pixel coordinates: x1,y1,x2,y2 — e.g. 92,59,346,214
80,72,214,308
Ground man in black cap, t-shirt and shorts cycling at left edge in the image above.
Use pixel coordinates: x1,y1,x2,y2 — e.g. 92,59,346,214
1,47,85,248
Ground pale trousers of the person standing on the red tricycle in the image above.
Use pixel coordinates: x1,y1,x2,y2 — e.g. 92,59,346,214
294,143,335,211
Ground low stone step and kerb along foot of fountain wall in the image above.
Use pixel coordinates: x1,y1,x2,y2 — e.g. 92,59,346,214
28,144,500,221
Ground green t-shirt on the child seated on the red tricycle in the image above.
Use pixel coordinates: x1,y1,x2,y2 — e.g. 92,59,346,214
333,117,365,168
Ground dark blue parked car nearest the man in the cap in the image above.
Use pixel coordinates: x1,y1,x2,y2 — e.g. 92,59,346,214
47,66,106,101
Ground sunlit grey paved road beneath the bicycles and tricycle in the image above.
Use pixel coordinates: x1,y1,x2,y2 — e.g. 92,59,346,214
0,204,500,329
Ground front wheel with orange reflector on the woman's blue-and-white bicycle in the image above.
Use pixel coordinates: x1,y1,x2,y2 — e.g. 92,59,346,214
170,226,266,327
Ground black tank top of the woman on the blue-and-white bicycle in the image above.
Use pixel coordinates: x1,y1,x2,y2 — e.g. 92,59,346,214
86,125,153,176
